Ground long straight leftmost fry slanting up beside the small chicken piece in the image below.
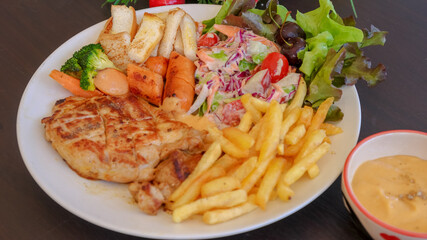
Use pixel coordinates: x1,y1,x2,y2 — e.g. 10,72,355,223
169,142,221,202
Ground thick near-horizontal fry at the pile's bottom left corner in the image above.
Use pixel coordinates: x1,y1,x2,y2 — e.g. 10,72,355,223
172,189,247,223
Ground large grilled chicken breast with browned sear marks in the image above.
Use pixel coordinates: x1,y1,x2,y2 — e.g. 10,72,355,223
42,95,206,183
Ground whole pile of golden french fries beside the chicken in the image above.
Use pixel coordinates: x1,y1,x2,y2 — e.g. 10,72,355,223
167,79,342,224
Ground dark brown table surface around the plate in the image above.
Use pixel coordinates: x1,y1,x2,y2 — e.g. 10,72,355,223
0,0,427,240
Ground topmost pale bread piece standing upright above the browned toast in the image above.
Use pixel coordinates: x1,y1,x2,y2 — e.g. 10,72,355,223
109,5,138,39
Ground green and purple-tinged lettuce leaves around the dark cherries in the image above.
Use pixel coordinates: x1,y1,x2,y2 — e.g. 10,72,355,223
203,0,387,120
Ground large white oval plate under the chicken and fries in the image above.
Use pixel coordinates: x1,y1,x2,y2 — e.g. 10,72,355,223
16,4,360,239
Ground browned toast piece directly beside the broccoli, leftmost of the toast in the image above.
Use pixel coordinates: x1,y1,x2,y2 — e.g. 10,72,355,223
99,32,132,71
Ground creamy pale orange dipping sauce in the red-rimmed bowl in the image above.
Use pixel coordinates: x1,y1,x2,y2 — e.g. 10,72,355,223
352,155,427,233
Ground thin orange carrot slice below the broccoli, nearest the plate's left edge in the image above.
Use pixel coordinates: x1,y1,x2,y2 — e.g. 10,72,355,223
49,69,103,97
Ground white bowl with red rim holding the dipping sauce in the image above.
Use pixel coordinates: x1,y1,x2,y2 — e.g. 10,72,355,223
341,130,427,240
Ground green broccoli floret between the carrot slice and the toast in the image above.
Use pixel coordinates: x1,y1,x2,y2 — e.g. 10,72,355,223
61,43,117,91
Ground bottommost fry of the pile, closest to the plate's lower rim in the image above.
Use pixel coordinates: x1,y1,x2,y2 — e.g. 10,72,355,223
203,195,258,224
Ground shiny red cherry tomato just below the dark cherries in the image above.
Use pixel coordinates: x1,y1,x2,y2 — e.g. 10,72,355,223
261,52,289,83
